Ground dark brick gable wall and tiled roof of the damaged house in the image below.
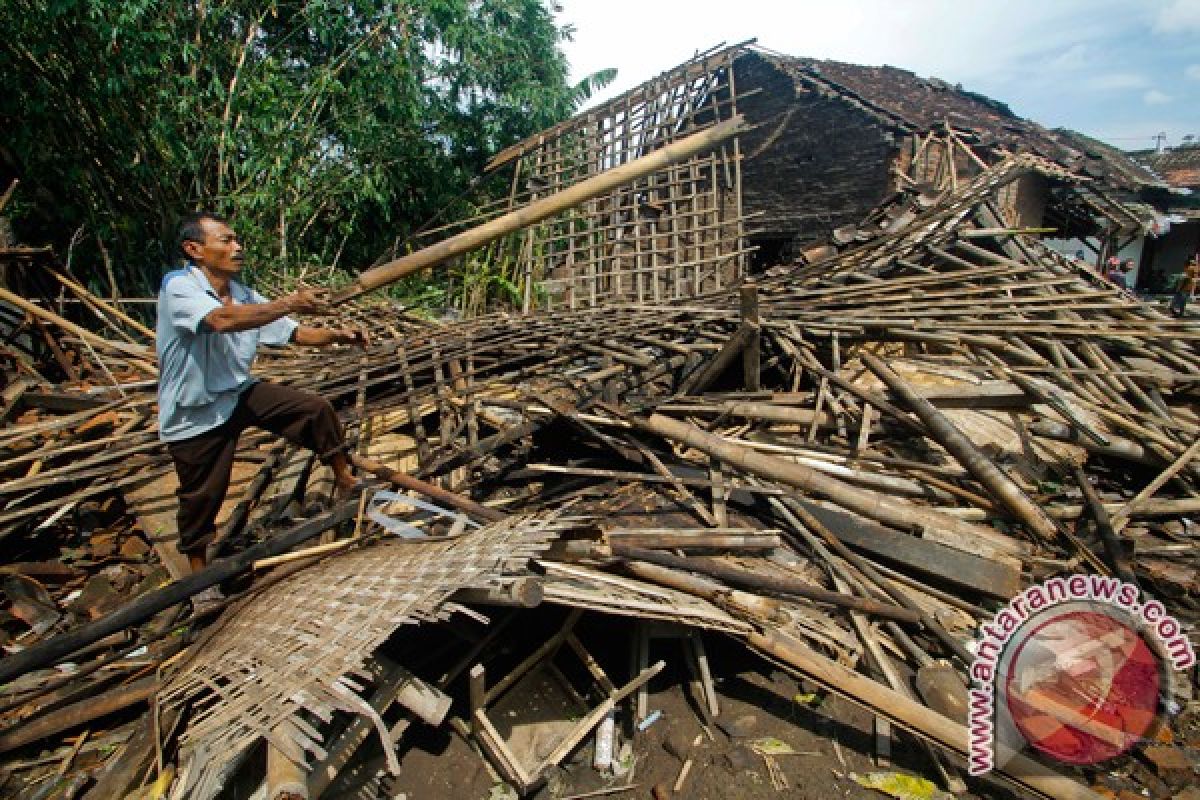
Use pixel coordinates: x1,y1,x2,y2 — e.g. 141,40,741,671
734,50,1063,264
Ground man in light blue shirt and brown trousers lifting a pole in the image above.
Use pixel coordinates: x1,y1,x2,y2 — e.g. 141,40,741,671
156,212,368,604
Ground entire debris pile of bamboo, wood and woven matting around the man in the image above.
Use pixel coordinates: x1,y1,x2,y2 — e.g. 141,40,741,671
0,156,1200,798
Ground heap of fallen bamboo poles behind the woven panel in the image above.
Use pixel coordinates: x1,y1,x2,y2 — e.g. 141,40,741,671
0,153,1200,796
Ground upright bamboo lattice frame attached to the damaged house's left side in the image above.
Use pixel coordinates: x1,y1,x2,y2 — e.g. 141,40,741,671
415,46,748,315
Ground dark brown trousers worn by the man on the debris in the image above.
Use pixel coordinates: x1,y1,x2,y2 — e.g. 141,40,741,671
167,381,344,555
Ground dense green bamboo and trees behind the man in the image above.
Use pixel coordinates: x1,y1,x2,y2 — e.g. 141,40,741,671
0,0,581,293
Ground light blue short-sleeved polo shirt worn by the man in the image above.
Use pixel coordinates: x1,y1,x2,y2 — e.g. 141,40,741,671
157,264,299,441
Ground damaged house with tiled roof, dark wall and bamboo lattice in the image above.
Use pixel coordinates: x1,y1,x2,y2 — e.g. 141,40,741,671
427,44,1162,314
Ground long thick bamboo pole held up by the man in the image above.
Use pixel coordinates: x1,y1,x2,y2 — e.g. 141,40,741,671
331,114,746,303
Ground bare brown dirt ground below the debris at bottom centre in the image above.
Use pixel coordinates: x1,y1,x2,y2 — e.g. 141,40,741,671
381,609,1014,800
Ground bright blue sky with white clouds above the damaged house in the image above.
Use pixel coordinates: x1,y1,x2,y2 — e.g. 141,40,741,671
558,0,1200,149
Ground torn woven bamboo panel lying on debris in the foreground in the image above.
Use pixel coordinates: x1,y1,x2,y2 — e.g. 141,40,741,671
158,515,577,796
